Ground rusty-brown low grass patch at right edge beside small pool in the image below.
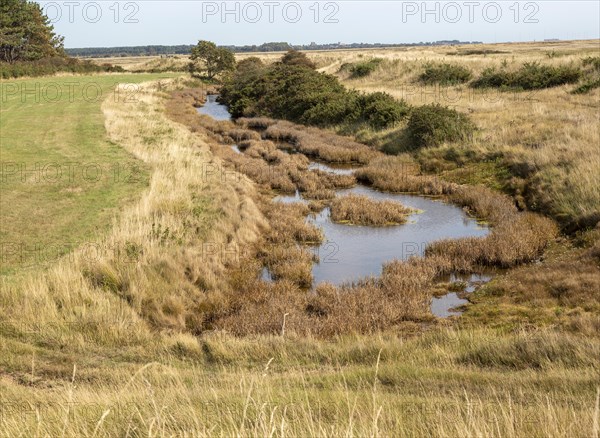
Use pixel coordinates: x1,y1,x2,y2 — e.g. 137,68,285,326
461,229,600,336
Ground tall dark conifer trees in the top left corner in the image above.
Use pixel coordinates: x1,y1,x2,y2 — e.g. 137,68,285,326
0,0,65,63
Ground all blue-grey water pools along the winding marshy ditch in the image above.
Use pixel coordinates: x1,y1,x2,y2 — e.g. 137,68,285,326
198,95,491,318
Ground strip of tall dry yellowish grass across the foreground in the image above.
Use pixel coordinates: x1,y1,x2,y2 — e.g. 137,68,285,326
0,330,600,438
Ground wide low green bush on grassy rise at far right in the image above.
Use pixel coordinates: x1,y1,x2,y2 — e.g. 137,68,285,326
472,62,581,90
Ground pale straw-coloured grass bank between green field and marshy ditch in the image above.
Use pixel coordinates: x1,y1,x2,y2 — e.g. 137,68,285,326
1,81,265,346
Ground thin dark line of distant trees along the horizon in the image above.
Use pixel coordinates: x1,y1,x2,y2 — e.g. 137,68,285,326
66,40,481,58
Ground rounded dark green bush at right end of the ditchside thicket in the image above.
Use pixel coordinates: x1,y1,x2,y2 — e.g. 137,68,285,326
407,104,475,148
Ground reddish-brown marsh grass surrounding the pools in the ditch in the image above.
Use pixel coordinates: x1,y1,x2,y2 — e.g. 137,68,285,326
173,90,556,338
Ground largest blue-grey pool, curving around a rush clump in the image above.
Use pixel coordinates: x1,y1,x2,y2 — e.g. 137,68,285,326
308,185,489,285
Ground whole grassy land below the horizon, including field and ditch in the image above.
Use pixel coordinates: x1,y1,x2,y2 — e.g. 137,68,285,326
0,3,600,438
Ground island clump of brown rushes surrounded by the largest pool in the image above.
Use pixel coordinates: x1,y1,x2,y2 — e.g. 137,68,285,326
331,195,413,227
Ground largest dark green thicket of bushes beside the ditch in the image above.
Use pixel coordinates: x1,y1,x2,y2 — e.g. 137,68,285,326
221,55,408,129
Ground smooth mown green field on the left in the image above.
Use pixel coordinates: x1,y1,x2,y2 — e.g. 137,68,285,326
0,74,173,275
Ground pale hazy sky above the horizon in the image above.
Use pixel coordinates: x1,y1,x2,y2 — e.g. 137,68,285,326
39,0,600,48
